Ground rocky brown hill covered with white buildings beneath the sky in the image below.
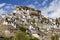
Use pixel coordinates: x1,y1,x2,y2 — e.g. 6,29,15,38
0,6,60,40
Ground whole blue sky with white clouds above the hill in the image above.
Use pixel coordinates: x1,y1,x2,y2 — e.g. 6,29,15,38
0,0,60,18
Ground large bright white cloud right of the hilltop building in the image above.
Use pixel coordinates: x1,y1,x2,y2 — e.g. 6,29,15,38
42,0,60,18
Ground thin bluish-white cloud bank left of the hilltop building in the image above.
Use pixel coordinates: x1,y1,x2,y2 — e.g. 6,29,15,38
0,3,16,15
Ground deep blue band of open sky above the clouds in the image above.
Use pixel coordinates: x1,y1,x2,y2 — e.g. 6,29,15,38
0,0,53,8
